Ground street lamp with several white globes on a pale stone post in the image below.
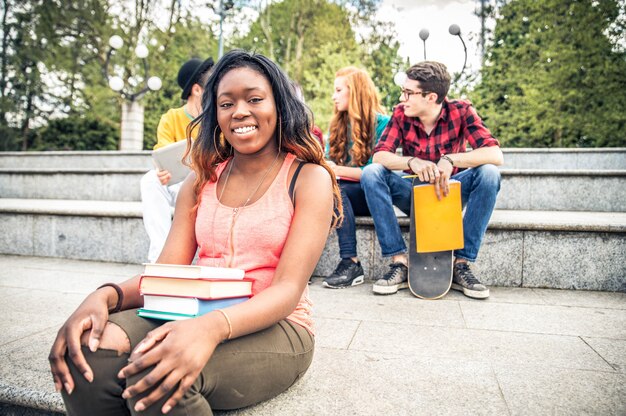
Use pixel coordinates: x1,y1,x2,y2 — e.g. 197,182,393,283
103,35,163,150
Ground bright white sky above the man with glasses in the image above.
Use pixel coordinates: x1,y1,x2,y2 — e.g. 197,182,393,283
377,0,480,73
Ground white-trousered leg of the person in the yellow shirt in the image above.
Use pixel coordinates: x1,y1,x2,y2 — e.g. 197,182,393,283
141,170,180,263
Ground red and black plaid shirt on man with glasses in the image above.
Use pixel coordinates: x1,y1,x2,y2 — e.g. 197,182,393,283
374,98,500,174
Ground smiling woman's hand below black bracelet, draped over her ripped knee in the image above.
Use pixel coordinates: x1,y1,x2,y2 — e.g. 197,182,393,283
48,288,117,394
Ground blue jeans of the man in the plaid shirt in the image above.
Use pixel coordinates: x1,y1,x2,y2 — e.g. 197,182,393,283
361,163,500,261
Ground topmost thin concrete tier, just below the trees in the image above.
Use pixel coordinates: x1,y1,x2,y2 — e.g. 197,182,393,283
0,147,626,170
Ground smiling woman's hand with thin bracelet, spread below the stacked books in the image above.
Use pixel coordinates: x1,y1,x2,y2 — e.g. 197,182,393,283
118,315,221,413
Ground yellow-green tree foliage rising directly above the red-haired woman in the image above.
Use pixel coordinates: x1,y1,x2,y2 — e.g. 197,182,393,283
233,0,400,129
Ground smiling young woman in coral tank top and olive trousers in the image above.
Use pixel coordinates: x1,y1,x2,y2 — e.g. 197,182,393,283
50,51,342,415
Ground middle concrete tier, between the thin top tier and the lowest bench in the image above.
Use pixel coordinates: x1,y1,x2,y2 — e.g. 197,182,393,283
0,168,626,212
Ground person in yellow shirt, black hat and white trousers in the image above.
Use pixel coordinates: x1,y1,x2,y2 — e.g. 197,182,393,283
141,58,213,263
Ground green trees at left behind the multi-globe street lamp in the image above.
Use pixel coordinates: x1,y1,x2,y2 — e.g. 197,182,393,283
0,0,217,150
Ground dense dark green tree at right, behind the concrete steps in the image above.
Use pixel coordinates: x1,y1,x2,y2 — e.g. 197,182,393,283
471,0,626,147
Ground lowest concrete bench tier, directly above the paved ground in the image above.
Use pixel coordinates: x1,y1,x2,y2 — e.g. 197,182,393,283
0,198,626,291
